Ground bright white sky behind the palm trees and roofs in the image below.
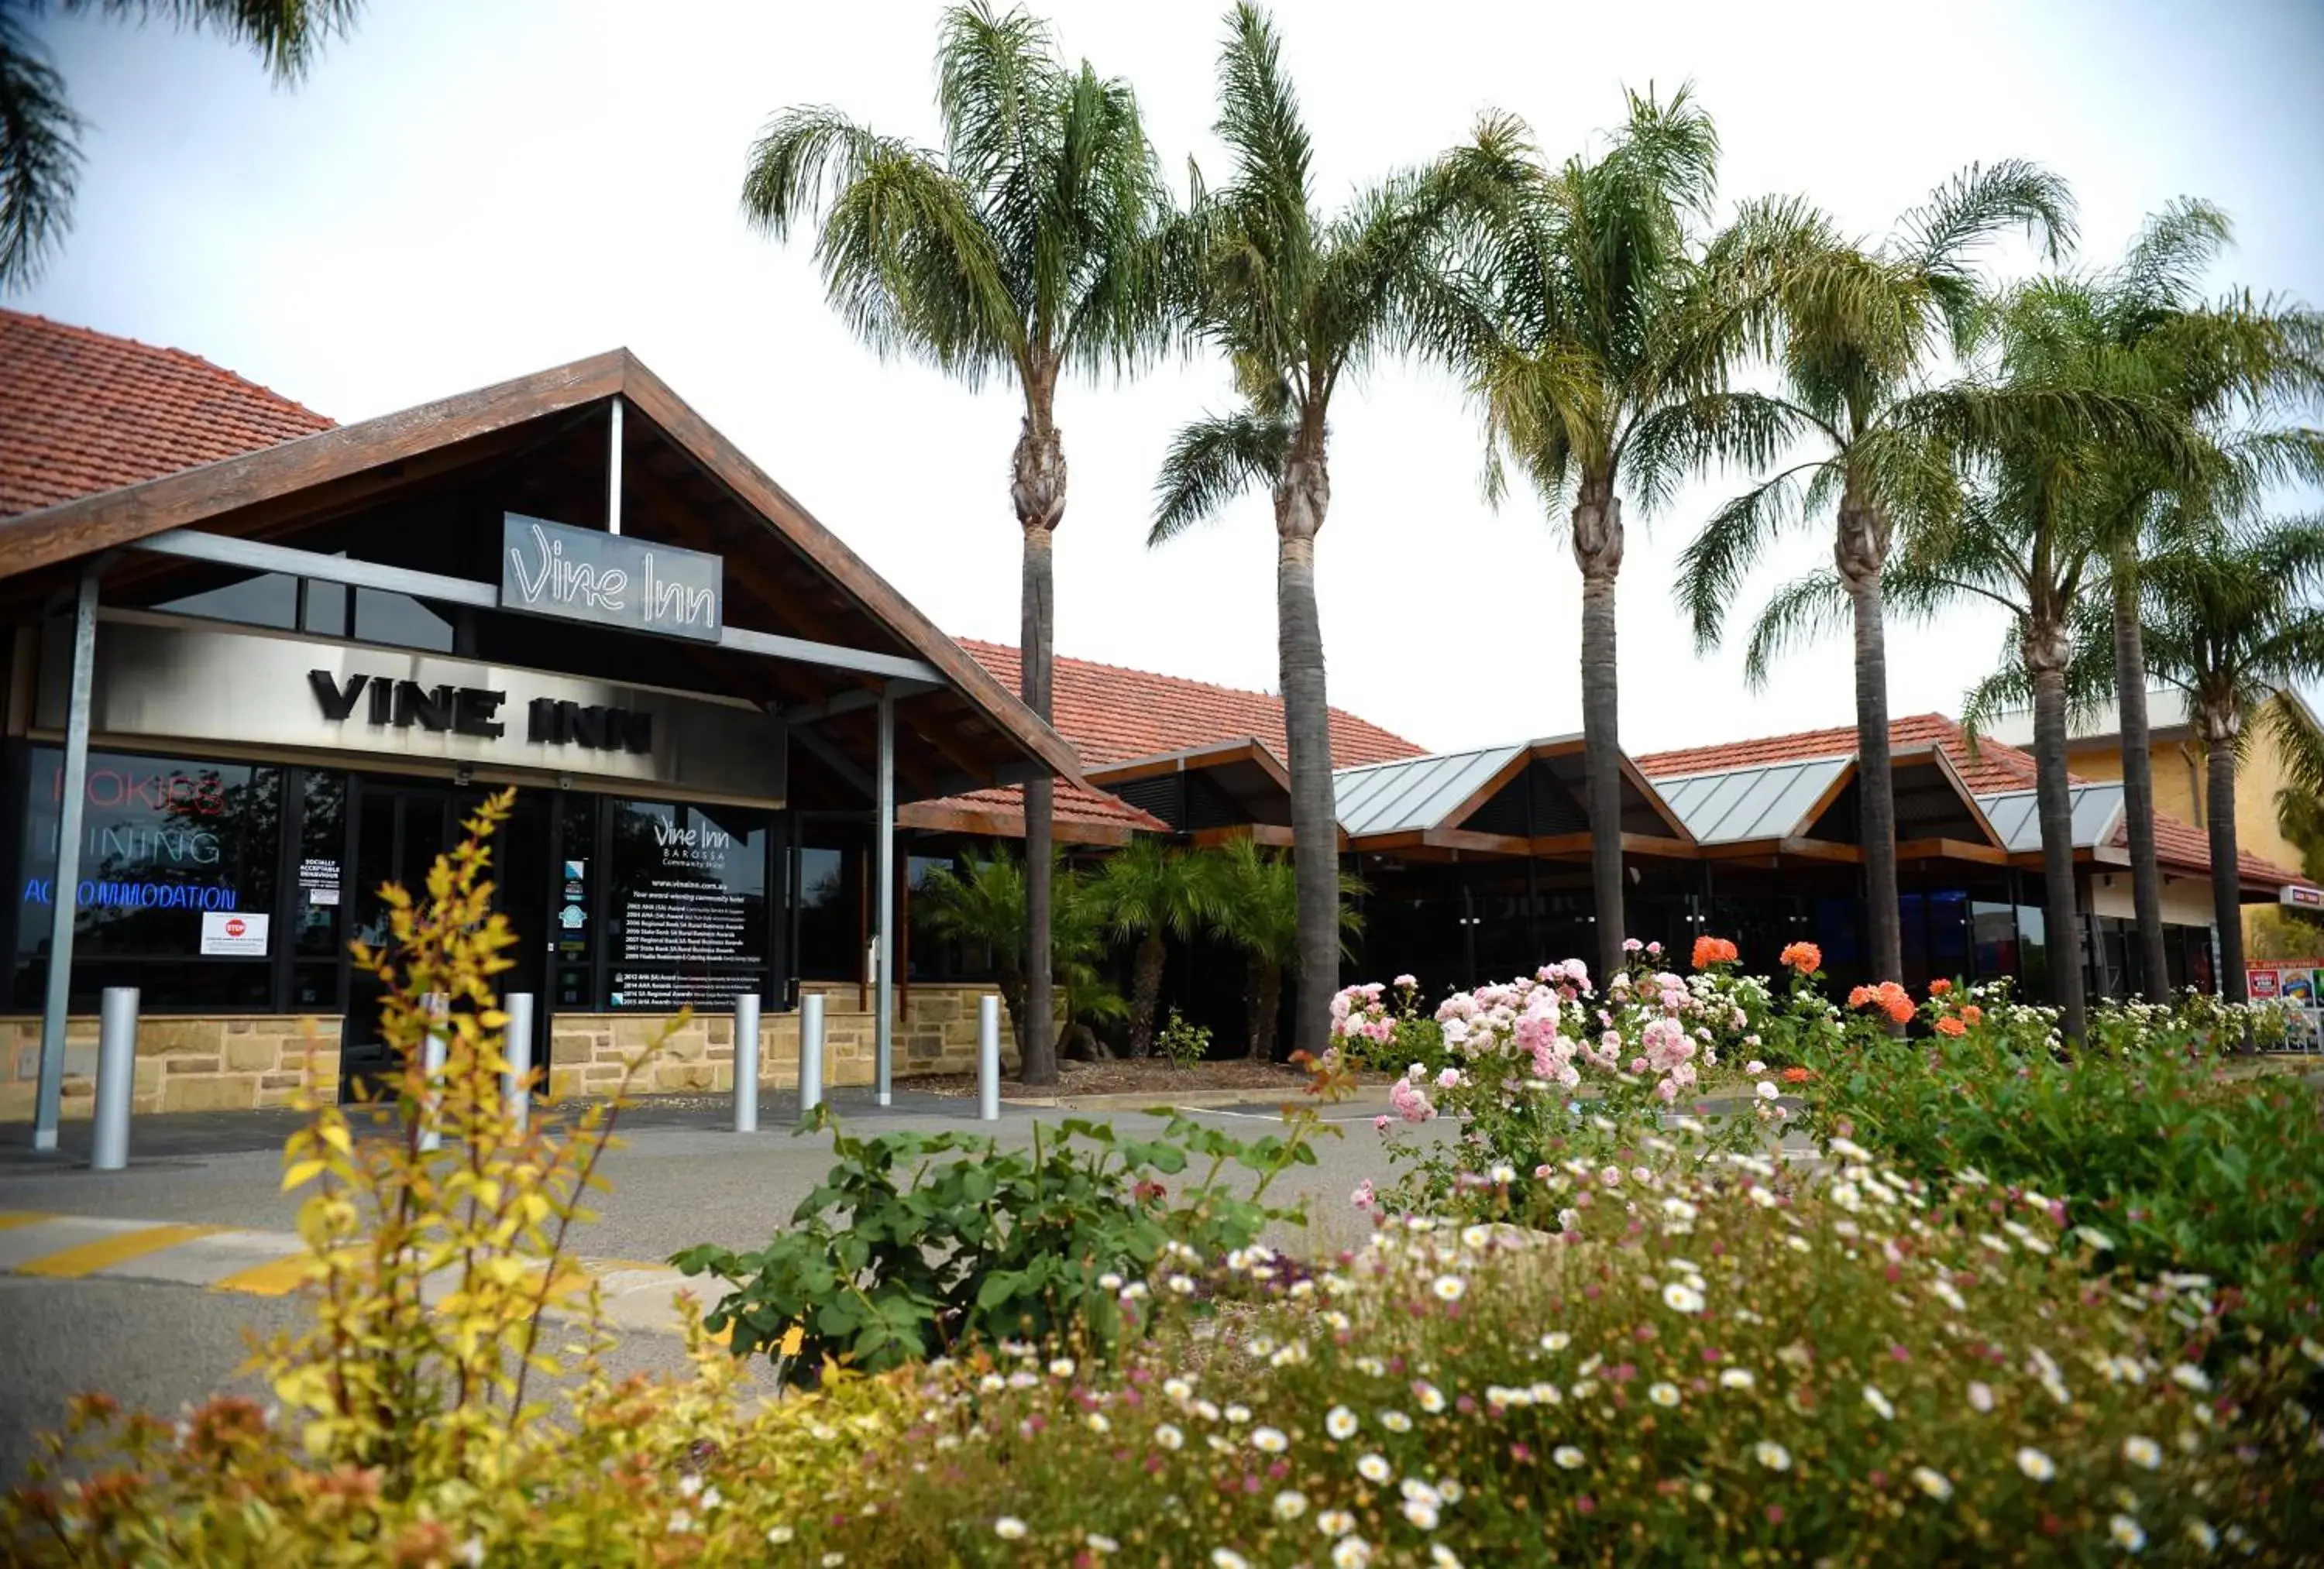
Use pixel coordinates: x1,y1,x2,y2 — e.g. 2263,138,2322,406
7,0,2324,750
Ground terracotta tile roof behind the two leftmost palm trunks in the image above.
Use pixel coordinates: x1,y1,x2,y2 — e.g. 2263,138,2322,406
960,637,1422,767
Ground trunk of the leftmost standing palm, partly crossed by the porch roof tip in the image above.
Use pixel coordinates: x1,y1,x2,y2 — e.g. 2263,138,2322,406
1009,386,1064,1083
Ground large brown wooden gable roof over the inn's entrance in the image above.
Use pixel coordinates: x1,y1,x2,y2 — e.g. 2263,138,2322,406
0,348,1081,800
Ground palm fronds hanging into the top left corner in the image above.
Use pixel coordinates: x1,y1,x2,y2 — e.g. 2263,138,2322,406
0,0,363,288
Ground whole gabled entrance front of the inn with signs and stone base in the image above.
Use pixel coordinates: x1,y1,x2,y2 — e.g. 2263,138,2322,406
0,344,1081,1148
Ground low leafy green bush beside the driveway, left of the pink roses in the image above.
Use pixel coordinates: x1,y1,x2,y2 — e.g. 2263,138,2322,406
672,1114,1322,1381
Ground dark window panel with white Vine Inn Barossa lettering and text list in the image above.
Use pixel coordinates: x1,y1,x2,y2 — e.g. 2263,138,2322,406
607,802,767,1009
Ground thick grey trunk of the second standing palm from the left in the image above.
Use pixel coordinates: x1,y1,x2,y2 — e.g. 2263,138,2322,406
1269,434,1339,1058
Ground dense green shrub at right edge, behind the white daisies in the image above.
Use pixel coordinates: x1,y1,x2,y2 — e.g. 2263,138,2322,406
1813,1009,2324,1332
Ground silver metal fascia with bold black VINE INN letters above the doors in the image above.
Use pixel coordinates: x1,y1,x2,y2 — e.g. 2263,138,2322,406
35,609,786,809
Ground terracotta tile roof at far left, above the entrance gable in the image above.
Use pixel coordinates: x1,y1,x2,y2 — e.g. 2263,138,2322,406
0,311,332,516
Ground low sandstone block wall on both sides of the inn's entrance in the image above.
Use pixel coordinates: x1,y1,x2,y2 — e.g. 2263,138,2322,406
0,986,1016,1123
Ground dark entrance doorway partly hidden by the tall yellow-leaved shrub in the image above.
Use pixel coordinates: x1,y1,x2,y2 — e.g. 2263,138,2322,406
339,774,555,1100
